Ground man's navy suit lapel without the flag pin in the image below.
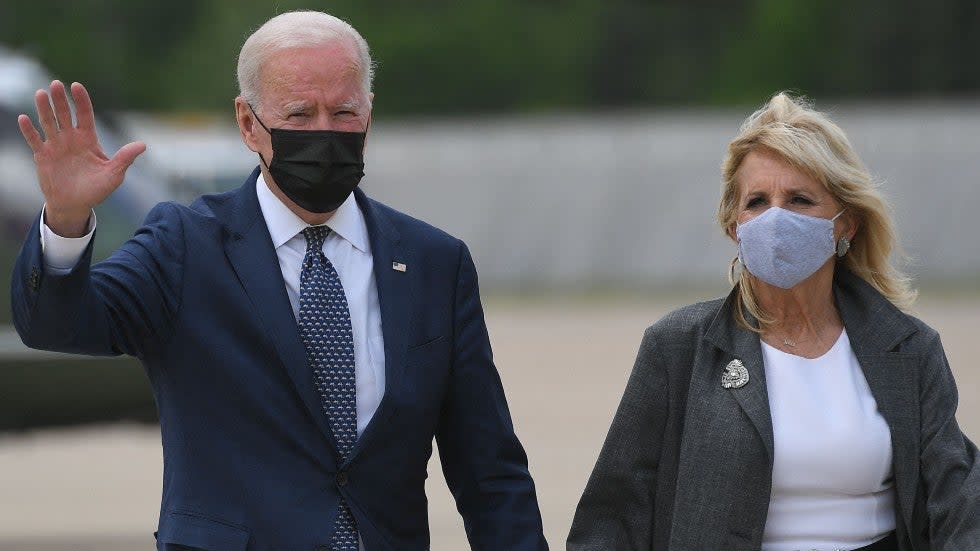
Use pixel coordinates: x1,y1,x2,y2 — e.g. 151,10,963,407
225,169,336,461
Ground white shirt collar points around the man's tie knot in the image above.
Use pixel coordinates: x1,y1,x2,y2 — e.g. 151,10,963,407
255,173,371,253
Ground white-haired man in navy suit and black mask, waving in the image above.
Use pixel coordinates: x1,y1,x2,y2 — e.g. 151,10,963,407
13,12,547,551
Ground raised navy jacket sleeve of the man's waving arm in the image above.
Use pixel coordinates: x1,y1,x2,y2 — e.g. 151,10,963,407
11,203,184,358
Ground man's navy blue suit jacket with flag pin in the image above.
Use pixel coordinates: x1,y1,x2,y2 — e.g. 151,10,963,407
12,169,547,551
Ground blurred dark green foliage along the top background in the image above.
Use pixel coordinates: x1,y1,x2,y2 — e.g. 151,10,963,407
0,0,980,115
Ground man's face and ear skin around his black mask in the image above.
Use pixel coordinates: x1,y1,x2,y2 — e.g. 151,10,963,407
235,41,372,222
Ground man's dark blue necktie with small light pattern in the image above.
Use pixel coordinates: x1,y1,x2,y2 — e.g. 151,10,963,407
299,226,359,551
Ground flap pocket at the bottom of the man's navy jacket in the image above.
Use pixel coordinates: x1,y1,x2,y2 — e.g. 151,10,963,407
156,512,249,551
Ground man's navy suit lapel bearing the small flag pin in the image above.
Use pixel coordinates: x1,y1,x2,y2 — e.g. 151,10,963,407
348,189,416,462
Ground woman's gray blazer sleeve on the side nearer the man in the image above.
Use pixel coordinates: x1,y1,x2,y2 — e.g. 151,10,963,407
567,328,669,551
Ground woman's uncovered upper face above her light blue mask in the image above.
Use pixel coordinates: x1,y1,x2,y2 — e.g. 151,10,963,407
729,149,851,239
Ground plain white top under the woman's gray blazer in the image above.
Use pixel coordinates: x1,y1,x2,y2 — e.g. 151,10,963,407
762,331,895,551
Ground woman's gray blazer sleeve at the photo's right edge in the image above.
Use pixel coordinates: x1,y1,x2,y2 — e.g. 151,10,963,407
919,334,980,550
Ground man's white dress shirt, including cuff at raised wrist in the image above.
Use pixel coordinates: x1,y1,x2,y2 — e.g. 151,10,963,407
41,178,385,436
